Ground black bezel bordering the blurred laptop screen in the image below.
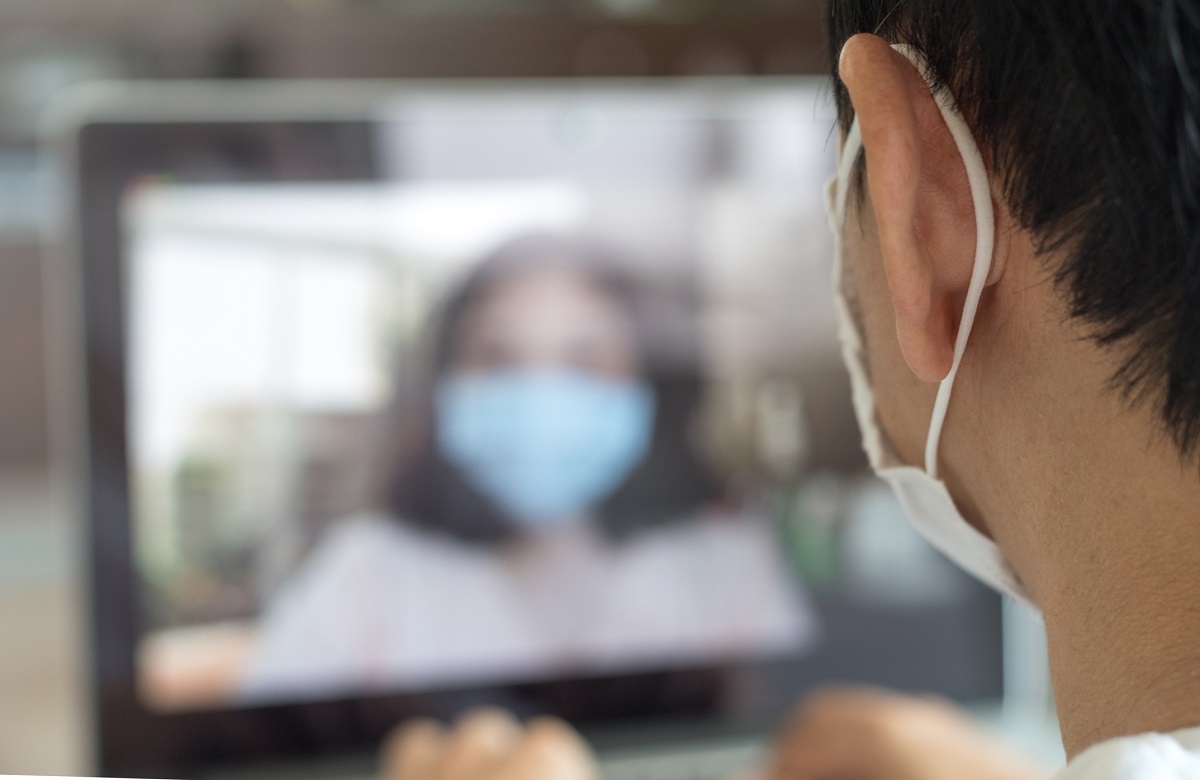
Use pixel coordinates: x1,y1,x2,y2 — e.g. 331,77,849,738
74,105,1002,776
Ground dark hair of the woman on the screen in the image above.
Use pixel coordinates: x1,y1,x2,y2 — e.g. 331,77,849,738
376,234,720,545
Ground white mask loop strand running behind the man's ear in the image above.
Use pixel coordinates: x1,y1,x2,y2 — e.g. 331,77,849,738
892,43,996,479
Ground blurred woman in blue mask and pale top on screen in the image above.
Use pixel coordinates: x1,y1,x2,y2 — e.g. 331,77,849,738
242,230,812,698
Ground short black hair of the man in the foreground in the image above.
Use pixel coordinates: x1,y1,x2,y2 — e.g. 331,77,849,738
827,0,1200,458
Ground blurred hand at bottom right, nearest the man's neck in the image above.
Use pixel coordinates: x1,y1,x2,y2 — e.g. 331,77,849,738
766,688,1050,780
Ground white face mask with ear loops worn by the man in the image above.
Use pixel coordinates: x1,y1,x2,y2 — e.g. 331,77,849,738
826,46,1037,608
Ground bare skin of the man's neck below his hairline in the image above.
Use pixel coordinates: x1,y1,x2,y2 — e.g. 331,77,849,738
960,256,1200,756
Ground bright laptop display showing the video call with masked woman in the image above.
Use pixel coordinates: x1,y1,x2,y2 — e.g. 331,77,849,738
124,88,988,710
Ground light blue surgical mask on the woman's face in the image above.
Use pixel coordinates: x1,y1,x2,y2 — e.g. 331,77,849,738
437,370,655,530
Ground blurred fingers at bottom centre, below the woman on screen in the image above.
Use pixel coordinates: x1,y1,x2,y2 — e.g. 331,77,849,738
380,709,600,780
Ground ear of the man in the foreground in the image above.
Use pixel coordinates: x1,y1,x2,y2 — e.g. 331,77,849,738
838,34,976,382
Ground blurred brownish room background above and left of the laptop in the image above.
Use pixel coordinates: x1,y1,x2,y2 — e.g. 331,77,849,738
0,0,824,774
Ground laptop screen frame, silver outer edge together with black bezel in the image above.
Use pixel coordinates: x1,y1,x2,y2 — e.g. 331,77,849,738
55,78,1003,776
